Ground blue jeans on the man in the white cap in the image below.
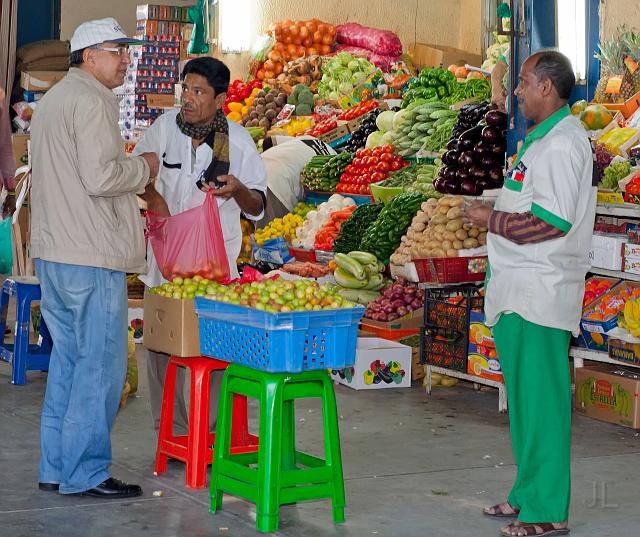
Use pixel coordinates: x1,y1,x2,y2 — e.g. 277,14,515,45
36,259,127,494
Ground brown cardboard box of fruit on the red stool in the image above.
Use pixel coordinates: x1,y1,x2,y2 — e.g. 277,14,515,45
143,293,200,356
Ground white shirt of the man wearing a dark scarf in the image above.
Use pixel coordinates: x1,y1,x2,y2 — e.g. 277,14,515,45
133,110,267,287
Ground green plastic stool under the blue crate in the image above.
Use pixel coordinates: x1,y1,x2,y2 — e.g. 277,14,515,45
210,364,345,532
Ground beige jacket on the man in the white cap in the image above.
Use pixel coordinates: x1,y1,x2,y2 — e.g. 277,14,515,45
31,68,149,272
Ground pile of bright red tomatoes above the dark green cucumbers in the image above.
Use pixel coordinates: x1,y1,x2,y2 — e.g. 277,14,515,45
336,144,409,195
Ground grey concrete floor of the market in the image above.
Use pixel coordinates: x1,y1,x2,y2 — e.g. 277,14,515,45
0,352,640,537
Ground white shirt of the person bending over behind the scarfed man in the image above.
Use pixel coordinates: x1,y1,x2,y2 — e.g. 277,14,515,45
262,136,336,211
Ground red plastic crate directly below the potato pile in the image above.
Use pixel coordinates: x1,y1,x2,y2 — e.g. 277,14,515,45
413,255,487,283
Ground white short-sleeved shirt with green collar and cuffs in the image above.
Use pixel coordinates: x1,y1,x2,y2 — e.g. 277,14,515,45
485,108,596,334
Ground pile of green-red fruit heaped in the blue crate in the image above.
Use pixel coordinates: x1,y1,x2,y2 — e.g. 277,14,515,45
206,279,356,313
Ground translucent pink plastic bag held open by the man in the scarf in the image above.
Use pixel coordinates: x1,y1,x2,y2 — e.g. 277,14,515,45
147,192,229,281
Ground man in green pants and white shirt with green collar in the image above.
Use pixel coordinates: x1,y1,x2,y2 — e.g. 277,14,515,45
465,51,596,536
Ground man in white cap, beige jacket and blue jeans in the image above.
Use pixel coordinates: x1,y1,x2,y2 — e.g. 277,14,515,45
31,18,159,499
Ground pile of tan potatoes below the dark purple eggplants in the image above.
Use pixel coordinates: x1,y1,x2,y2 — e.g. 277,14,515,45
391,196,487,265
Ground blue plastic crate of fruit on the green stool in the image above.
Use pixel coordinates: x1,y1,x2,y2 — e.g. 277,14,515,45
195,297,364,373
